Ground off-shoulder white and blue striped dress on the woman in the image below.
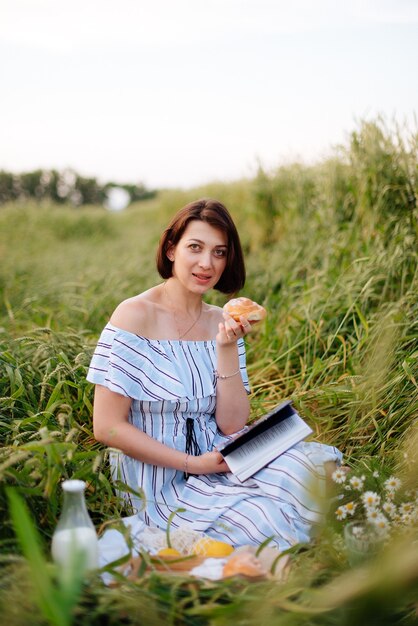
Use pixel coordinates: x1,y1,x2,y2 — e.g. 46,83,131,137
87,323,341,550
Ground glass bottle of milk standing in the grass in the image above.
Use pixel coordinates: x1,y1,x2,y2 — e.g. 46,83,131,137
51,480,99,570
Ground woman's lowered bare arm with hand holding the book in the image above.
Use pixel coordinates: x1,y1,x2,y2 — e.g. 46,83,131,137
93,385,229,474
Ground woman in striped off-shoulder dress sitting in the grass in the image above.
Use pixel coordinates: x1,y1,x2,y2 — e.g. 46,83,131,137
88,199,340,549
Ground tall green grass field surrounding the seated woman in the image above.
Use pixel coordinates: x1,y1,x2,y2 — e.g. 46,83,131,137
0,120,418,626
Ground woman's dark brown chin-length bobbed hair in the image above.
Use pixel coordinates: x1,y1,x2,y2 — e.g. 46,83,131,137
157,198,245,294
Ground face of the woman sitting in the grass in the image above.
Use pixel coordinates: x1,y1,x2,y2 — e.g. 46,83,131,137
167,220,228,293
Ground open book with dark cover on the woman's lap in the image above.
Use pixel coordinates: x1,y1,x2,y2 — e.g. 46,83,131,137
218,400,312,481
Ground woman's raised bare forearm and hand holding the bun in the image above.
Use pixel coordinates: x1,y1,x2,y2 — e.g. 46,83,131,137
215,314,251,435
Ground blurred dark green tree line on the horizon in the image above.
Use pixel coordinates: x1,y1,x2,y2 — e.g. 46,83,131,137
0,169,156,206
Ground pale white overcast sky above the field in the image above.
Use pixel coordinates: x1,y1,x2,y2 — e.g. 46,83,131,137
0,0,418,189
